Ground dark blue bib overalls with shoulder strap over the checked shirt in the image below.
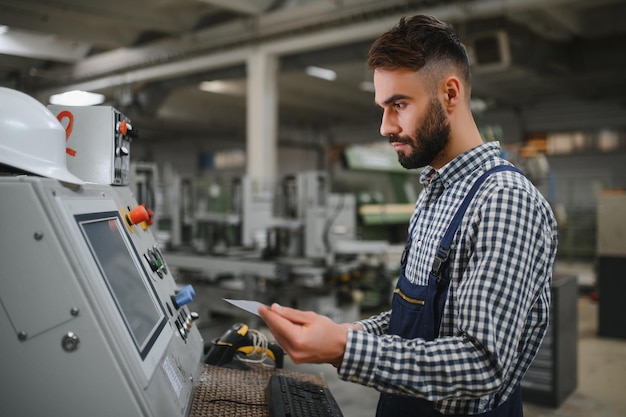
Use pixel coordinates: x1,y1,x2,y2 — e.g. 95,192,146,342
376,165,523,417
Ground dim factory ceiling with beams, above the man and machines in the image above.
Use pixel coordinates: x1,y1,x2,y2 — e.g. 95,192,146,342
0,0,626,145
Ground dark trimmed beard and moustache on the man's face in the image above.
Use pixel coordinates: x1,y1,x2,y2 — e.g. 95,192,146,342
389,97,450,169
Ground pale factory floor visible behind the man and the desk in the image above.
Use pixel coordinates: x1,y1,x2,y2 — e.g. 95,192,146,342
201,265,626,417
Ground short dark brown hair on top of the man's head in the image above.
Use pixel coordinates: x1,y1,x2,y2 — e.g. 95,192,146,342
367,15,470,88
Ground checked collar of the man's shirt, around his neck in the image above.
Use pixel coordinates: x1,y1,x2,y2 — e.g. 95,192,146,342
420,142,500,188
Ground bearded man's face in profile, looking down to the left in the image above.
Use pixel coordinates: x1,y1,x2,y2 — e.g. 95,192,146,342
374,70,450,169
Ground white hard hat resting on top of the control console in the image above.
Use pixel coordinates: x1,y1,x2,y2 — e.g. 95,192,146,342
0,87,84,184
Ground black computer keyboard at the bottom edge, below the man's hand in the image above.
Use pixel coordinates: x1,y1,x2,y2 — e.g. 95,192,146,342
267,375,343,417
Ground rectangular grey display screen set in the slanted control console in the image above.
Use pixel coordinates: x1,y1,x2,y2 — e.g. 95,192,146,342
76,212,166,359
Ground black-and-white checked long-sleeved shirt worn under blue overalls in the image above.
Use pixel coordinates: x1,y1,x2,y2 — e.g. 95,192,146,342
338,143,557,414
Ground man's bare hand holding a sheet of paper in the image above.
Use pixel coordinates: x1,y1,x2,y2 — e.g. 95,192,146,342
259,304,352,367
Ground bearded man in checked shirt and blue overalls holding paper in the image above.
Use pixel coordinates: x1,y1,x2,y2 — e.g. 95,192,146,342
259,15,557,417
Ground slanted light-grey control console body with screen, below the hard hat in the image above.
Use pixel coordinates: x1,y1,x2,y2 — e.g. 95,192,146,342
0,176,203,417
